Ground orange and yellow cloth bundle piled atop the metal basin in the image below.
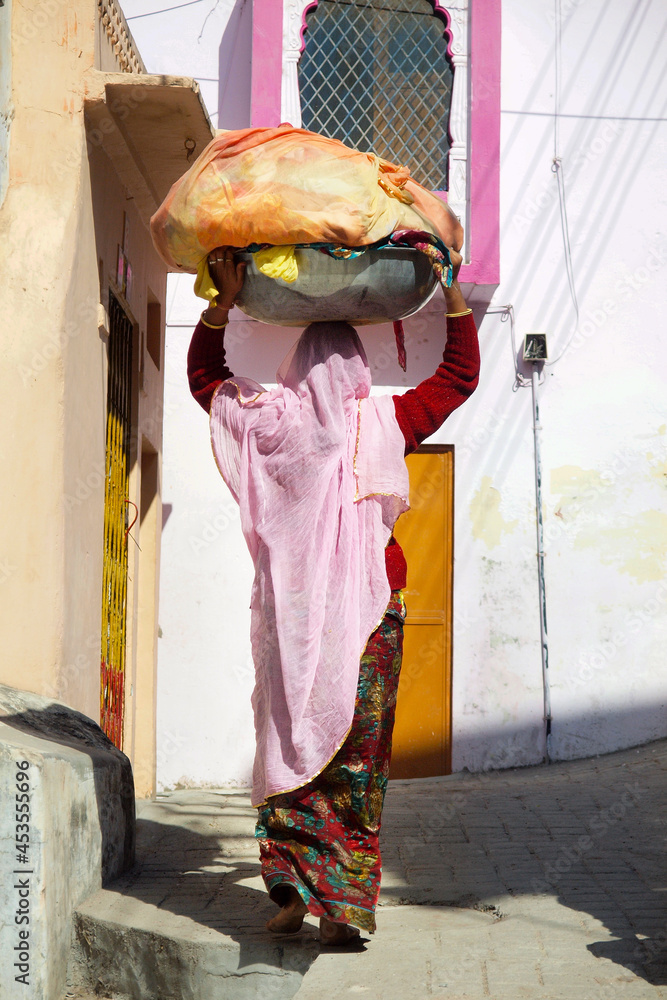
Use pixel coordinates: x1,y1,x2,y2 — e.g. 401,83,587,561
151,125,463,273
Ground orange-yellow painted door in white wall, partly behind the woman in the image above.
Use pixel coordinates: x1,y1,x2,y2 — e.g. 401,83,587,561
389,445,454,778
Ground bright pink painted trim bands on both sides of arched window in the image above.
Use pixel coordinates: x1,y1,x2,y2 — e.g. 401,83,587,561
250,0,501,285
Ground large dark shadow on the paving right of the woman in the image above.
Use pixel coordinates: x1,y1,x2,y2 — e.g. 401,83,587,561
383,741,667,986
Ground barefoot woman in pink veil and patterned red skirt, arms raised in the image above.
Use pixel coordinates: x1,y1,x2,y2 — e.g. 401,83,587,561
188,247,479,944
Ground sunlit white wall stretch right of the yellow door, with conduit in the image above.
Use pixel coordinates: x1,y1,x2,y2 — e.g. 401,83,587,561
450,0,667,767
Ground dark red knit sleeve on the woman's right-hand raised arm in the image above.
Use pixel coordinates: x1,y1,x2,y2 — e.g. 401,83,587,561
394,313,479,455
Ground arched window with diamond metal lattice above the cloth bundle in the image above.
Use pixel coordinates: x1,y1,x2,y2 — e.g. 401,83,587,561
298,0,453,190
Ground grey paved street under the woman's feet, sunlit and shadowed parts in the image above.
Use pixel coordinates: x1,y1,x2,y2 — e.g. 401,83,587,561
78,742,667,1000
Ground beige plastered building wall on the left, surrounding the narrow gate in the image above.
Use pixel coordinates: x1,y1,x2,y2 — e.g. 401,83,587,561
0,0,166,794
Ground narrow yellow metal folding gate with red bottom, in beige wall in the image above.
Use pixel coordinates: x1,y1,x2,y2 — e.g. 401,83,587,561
100,292,132,749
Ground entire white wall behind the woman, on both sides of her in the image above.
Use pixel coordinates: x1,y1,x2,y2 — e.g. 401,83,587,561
126,0,667,787
